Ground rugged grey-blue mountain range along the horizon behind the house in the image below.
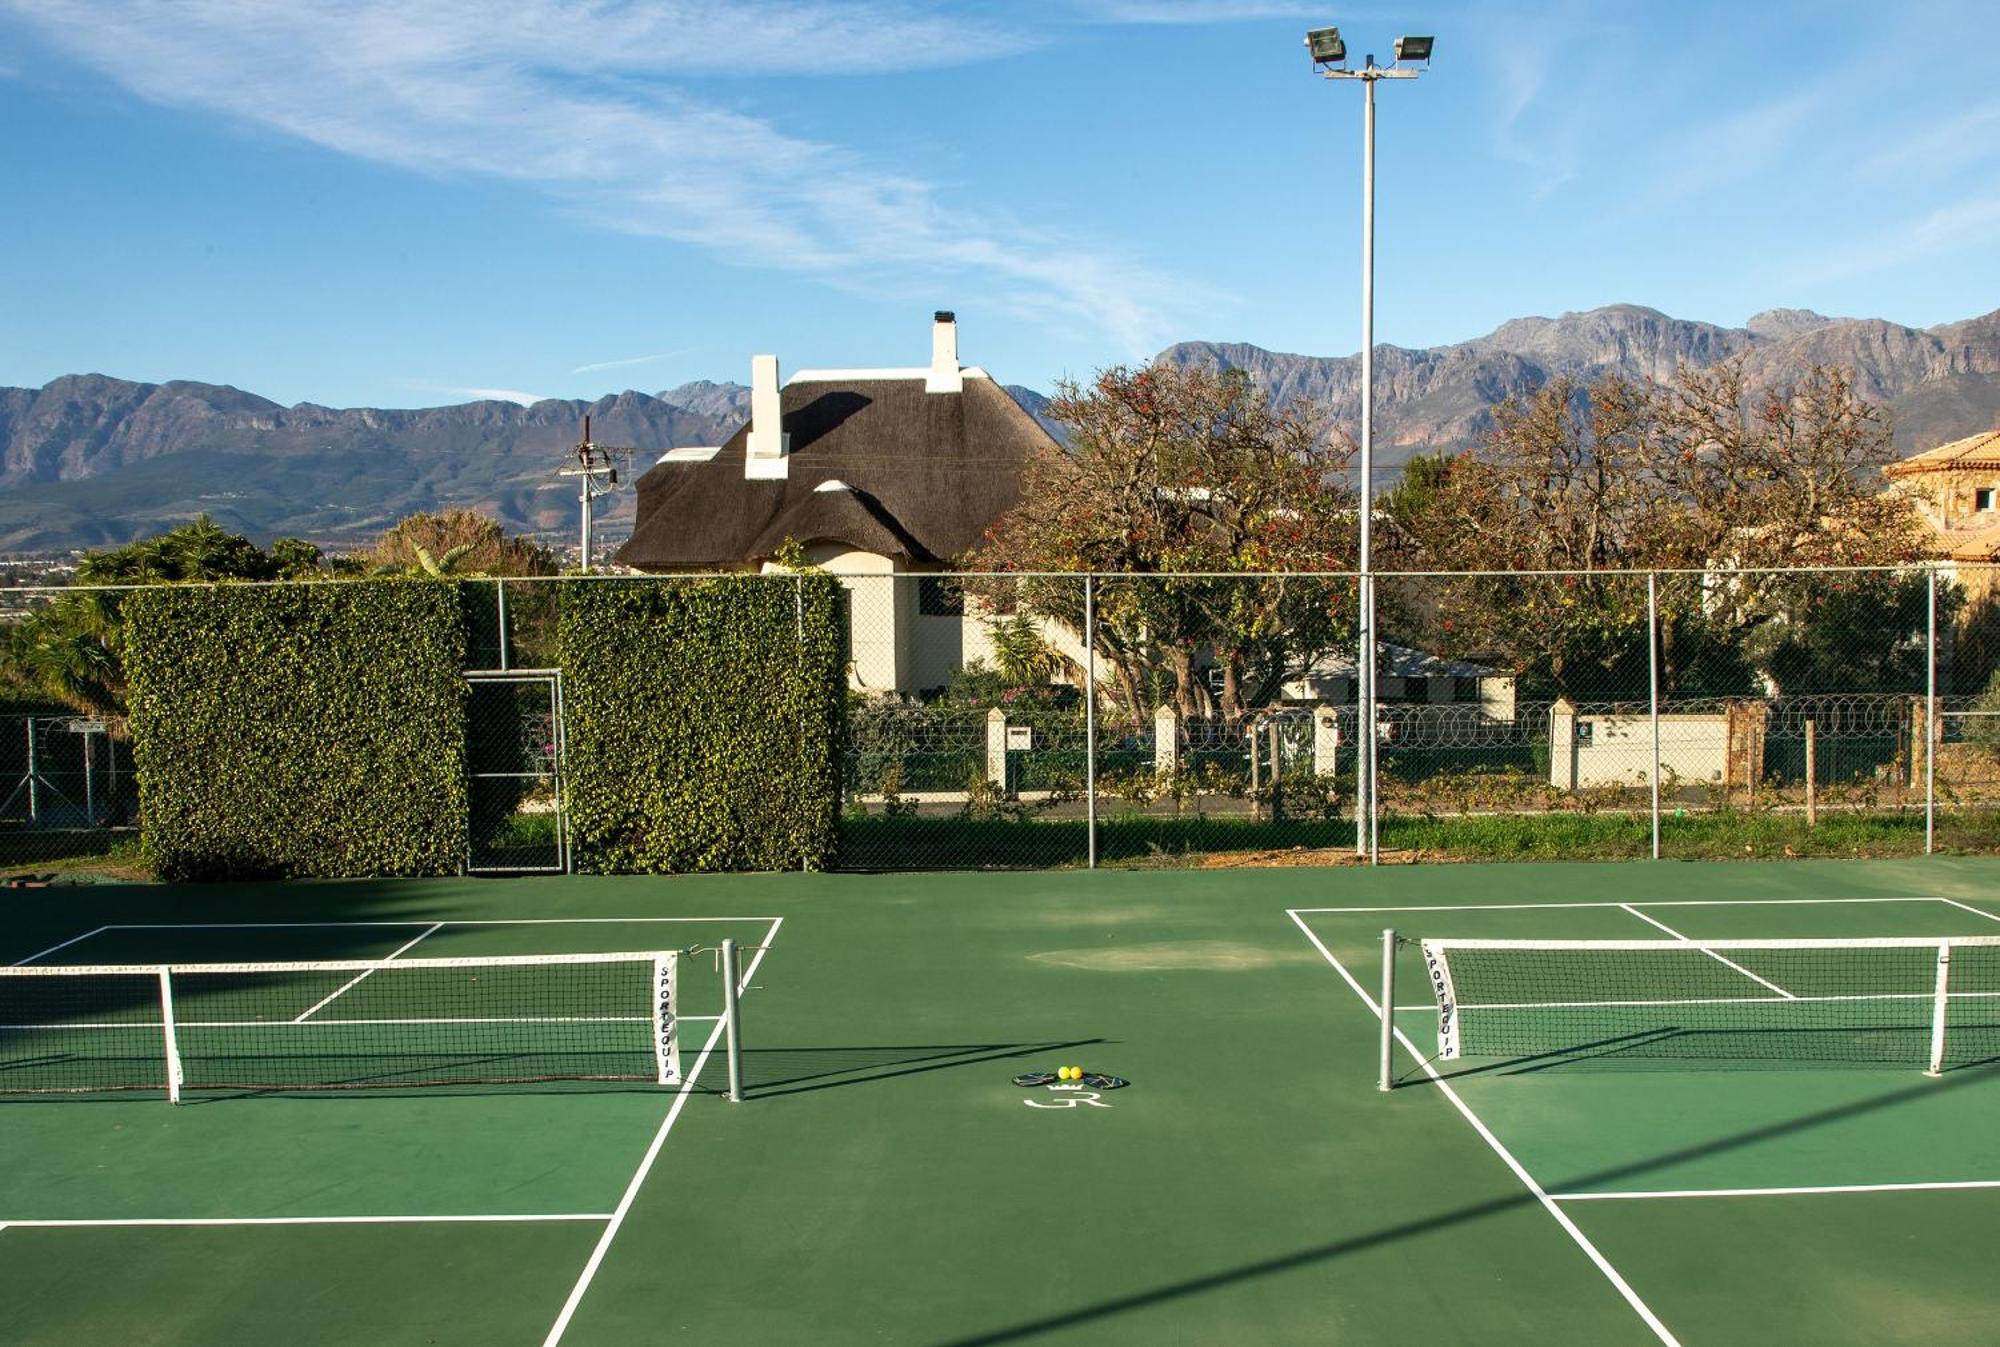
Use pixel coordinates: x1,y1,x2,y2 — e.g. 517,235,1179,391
0,304,2000,556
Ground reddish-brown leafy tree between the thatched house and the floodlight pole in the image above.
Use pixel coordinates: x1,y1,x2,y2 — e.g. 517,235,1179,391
972,366,1356,721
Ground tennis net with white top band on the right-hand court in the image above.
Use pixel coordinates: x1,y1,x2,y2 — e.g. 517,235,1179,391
1422,935,2000,1075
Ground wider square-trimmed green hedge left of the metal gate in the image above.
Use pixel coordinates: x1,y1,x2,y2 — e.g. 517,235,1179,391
124,580,466,879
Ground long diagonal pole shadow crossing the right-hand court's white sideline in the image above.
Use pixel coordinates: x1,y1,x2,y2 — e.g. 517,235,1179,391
942,1073,1984,1347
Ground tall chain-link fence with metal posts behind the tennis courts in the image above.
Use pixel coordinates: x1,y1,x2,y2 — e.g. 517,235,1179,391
0,564,2000,871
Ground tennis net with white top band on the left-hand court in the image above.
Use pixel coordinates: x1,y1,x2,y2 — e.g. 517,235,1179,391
0,951,680,1099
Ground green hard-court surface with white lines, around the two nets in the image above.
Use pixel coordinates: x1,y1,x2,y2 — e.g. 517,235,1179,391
11,857,2000,1347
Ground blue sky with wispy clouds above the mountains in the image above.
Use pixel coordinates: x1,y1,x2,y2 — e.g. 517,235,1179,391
0,0,2000,406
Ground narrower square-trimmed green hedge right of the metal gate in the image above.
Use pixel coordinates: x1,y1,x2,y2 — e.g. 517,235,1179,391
556,574,846,873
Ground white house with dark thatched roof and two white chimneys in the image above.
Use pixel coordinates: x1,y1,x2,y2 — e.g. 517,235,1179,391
616,314,1054,693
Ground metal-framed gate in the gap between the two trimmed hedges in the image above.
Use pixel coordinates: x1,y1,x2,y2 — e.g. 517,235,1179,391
466,670,570,875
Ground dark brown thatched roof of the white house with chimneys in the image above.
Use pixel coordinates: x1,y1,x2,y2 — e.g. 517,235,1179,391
616,370,1052,572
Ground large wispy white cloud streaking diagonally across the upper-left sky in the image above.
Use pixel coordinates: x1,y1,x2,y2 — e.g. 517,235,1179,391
0,0,1200,356
